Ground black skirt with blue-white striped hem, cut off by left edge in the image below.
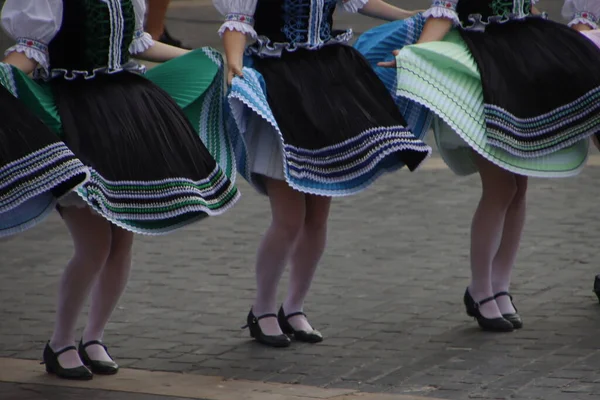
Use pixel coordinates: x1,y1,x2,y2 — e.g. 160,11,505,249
0,64,89,237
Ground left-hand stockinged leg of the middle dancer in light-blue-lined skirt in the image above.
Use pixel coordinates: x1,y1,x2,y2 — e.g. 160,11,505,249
253,178,305,335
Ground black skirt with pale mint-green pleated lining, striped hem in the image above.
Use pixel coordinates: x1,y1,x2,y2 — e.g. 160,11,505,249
397,24,600,177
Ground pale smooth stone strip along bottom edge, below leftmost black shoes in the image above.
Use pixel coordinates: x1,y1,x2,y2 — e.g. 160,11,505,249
0,358,435,400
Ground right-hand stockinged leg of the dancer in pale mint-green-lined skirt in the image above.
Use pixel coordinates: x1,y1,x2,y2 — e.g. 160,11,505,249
492,176,527,314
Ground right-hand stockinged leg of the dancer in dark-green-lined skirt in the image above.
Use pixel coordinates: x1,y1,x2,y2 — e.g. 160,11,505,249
83,225,133,361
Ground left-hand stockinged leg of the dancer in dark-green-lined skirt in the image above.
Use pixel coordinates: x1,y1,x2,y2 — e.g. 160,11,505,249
50,207,111,368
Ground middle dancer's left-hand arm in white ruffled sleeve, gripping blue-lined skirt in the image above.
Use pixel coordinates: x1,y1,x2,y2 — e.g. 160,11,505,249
213,0,257,84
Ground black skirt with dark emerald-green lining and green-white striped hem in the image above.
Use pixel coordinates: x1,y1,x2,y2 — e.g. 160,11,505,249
17,49,239,235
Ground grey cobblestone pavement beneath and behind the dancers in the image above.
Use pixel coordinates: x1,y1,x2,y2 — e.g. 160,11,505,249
0,1,600,400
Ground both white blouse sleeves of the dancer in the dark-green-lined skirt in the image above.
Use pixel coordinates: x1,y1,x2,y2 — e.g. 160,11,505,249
2,0,154,75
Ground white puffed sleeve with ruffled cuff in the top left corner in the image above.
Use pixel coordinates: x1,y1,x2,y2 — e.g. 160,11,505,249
2,0,63,72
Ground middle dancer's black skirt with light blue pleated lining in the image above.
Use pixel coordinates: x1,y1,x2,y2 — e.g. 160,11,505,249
228,45,431,196
